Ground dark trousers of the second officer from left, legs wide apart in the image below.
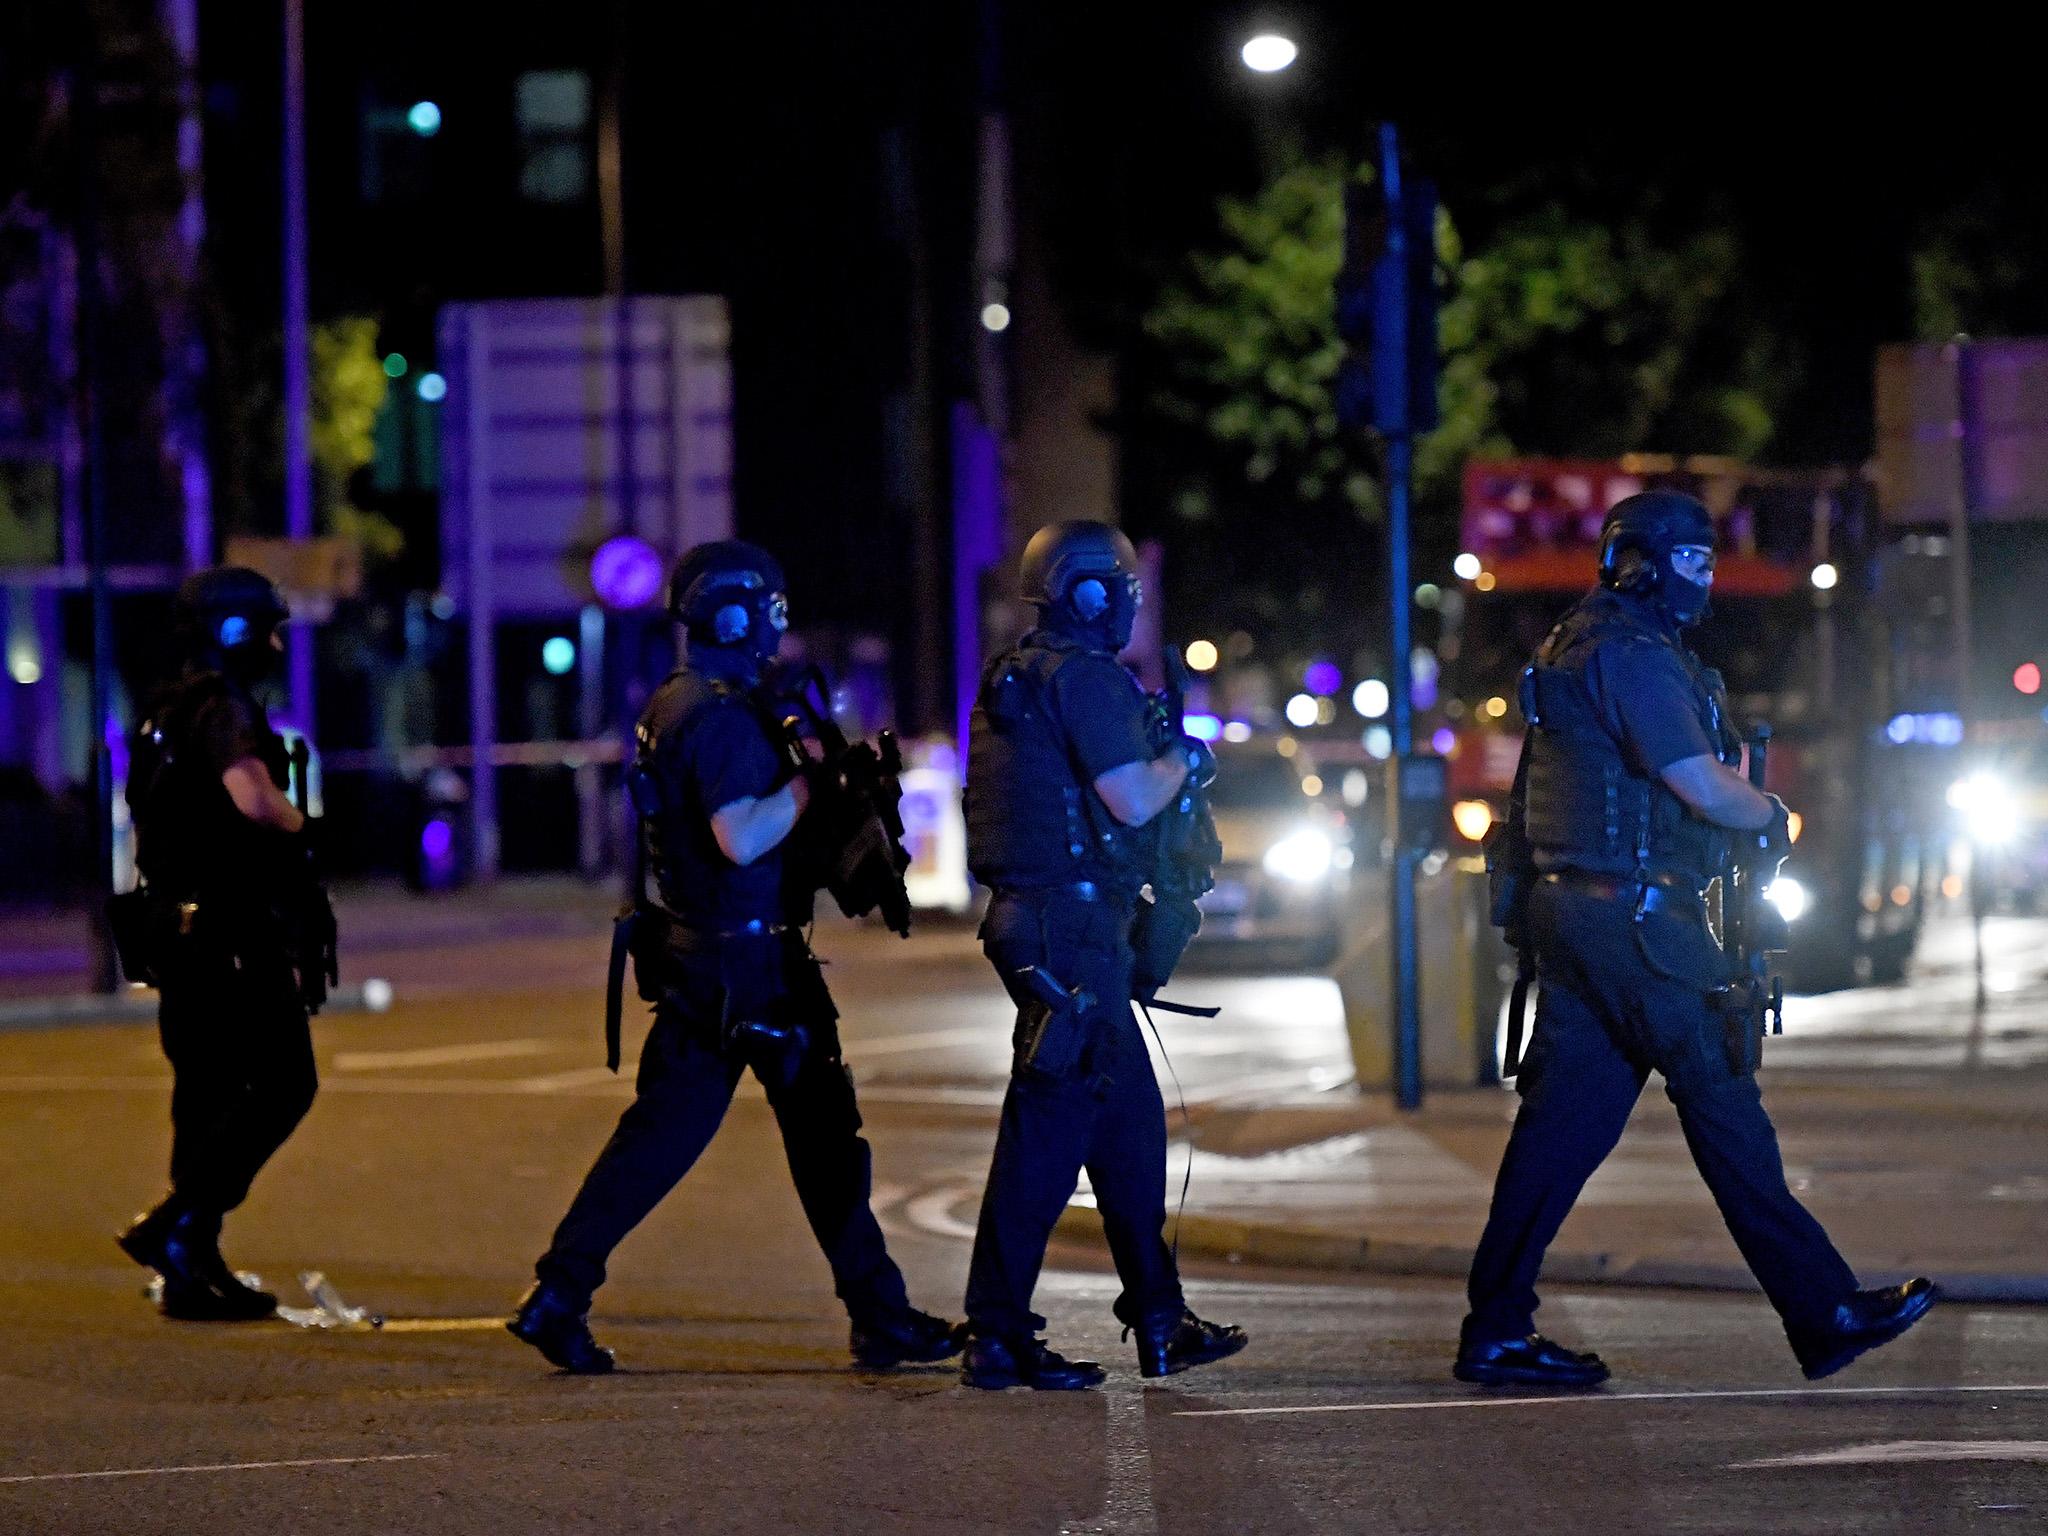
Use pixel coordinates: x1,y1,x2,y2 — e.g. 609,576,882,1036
535,958,909,1323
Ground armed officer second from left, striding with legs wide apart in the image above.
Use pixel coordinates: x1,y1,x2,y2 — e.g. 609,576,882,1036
508,541,963,1374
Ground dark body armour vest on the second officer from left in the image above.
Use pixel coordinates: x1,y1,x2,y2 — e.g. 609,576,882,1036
629,668,805,932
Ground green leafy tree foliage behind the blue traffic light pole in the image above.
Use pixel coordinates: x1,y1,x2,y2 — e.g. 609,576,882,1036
1126,160,1798,655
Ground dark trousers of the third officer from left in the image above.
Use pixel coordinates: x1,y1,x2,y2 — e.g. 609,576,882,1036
967,891,1186,1337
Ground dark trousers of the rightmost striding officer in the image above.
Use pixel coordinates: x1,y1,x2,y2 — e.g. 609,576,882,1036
1466,881,1855,1341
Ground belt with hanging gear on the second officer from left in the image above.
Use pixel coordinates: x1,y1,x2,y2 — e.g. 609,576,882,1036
604,901,811,1071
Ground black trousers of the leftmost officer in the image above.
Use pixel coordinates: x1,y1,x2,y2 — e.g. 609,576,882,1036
158,956,319,1214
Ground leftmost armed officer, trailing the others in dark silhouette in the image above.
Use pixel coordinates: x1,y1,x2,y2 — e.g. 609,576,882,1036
115,567,334,1321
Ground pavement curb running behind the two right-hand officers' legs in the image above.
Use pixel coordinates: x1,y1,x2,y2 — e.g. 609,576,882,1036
1055,1204,2048,1307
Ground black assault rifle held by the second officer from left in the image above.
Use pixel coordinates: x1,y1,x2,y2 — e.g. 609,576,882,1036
770,666,909,938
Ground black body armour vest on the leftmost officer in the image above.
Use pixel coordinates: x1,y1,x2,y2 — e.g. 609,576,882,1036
127,672,291,901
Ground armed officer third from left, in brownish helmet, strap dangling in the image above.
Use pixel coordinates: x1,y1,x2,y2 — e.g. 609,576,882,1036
963,522,1245,1391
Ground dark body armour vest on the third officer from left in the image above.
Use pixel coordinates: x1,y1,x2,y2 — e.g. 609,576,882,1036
965,631,1147,893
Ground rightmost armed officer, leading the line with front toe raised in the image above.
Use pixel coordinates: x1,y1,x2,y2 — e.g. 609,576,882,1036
1454,492,1933,1386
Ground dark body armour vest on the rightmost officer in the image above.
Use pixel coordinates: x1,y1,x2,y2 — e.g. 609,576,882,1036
1522,590,1741,885
